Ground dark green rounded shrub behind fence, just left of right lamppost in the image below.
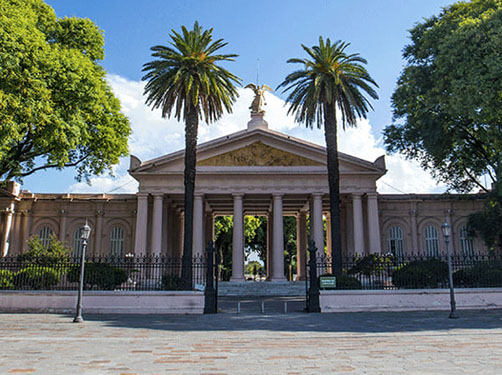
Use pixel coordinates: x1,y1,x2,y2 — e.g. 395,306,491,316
392,259,448,289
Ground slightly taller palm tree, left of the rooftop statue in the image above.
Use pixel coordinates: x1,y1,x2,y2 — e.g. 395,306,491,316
142,22,240,288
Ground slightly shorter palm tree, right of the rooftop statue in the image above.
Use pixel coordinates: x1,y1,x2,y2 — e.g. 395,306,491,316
277,37,378,275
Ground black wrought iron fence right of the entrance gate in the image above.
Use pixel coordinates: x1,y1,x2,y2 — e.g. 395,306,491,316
310,253,502,289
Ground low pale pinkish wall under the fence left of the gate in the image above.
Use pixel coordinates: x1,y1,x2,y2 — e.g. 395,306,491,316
0,290,204,314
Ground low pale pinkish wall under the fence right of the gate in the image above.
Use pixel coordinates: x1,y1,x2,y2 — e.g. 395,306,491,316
320,288,502,313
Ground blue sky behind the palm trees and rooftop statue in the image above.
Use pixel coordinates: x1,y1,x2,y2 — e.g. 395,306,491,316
23,0,454,192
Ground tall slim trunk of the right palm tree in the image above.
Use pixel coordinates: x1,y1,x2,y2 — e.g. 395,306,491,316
324,105,342,276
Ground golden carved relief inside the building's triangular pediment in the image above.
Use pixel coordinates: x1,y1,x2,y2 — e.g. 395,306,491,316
197,141,324,167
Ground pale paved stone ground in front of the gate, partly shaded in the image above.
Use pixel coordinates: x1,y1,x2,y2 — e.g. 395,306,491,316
0,310,502,375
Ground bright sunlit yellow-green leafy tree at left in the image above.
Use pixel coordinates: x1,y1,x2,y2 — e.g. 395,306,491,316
0,0,130,181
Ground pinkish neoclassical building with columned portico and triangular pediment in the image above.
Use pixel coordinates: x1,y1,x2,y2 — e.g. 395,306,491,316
0,113,486,281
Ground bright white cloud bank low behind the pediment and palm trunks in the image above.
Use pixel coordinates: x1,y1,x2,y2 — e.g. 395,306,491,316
69,75,444,193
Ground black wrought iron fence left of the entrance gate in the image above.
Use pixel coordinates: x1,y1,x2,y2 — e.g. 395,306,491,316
0,255,206,290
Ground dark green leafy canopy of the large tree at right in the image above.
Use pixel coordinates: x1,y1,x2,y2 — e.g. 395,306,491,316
384,0,502,192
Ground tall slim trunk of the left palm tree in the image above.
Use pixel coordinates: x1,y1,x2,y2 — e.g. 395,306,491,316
181,108,199,290
